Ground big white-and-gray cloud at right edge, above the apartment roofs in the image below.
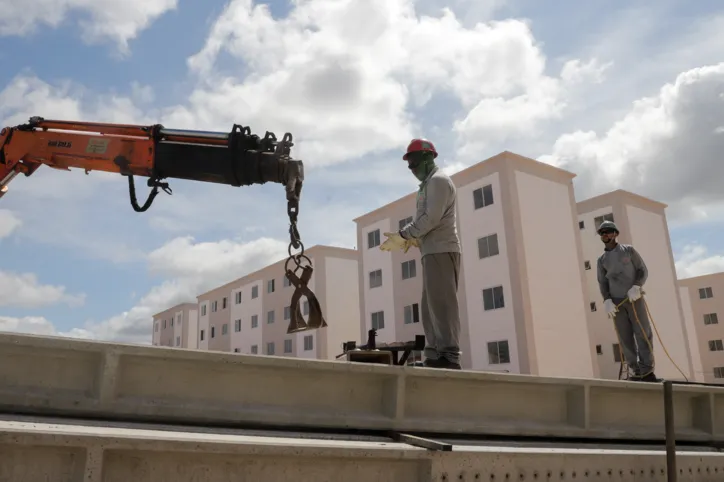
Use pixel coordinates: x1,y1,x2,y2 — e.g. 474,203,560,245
539,63,724,218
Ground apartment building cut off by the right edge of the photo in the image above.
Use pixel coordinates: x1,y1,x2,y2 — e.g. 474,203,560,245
679,273,724,383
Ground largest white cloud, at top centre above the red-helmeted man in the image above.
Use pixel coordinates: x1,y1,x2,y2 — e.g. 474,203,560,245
170,0,598,166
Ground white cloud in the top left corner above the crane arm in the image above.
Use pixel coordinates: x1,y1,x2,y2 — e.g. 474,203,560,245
0,0,178,54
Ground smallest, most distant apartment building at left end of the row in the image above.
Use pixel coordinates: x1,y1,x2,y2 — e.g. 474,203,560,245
152,303,198,348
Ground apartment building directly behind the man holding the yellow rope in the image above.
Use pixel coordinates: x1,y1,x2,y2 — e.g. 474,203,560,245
577,190,700,380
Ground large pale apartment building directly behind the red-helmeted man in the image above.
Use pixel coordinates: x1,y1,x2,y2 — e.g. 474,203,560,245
354,151,598,377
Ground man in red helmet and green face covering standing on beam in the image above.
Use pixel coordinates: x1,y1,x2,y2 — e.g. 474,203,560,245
380,139,461,370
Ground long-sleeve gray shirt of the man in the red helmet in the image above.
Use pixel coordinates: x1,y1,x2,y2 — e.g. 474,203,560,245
400,167,461,257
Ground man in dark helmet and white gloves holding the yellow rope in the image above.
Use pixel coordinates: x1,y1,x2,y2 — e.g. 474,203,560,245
597,221,660,382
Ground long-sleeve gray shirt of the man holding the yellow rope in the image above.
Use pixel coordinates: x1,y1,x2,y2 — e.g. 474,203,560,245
597,244,649,300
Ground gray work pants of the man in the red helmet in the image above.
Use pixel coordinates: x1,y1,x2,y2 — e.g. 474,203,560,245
420,253,460,363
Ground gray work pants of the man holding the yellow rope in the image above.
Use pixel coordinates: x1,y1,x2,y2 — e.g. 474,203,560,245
611,298,654,375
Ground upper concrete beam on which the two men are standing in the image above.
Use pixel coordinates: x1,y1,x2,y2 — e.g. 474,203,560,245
0,334,724,441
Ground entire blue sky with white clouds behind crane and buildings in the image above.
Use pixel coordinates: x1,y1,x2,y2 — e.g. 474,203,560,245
0,0,724,343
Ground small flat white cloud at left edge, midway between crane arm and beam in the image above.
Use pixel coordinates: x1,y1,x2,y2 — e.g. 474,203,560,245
0,271,85,308
